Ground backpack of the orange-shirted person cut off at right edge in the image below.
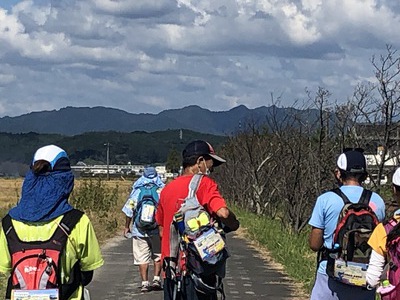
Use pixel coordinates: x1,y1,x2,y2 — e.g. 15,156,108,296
377,218,400,300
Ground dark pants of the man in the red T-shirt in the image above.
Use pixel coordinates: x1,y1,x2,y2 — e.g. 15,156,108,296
164,276,218,300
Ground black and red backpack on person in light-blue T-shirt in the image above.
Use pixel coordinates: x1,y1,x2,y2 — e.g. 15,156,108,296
326,189,379,287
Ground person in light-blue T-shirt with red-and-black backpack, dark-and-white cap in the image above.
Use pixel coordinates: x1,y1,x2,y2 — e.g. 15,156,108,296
308,149,385,300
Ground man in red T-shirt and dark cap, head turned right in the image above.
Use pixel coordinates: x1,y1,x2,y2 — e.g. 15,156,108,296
156,140,239,300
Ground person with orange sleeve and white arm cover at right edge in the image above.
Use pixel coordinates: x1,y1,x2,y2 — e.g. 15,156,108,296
367,168,400,300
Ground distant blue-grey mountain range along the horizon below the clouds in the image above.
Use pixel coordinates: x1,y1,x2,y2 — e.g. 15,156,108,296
0,105,318,136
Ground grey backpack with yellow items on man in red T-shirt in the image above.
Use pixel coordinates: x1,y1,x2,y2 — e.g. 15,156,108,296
171,174,229,298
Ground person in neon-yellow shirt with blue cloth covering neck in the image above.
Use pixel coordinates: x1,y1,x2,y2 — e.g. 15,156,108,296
0,145,104,300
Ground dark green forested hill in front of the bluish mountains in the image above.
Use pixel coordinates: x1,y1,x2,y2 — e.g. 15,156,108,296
0,130,226,172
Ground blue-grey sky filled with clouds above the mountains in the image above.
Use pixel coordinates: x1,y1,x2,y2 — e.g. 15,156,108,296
0,0,400,117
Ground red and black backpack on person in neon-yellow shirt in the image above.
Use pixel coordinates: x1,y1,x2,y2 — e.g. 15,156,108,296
2,209,83,300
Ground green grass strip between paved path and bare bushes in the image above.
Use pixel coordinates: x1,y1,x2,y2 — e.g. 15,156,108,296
232,206,316,294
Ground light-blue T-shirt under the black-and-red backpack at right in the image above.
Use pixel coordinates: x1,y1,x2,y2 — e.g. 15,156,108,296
308,185,385,274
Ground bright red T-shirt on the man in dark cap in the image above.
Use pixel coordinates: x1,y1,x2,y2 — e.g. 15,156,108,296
156,175,226,258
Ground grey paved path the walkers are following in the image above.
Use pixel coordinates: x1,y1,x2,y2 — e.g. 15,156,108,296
88,235,307,300
